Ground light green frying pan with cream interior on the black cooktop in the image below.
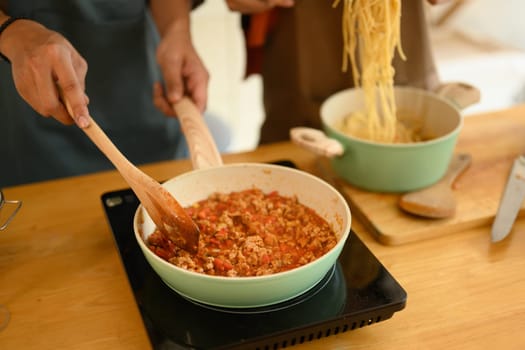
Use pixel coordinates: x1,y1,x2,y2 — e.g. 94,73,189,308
133,99,351,308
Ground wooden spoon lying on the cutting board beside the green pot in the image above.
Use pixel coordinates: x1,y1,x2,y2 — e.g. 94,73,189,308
399,154,472,219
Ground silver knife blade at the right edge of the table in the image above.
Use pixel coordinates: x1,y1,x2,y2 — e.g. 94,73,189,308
492,155,525,242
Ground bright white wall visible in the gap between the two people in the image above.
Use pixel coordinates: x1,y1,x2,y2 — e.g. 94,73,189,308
192,0,264,152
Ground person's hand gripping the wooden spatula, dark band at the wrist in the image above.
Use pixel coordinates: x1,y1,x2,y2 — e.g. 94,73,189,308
0,19,89,127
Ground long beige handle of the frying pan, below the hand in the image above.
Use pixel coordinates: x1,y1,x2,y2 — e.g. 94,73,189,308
173,97,223,169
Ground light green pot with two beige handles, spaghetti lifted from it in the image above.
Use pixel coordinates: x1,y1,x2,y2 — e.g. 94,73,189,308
290,84,479,192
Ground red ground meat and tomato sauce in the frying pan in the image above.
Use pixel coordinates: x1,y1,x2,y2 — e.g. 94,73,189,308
147,189,337,276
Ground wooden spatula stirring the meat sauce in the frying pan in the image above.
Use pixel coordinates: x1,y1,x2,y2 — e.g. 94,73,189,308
62,96,199,253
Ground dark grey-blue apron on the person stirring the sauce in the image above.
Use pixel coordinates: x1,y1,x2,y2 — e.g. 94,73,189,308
0,0,185,188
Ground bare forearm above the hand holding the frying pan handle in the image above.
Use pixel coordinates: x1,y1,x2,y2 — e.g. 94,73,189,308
150,0,192,36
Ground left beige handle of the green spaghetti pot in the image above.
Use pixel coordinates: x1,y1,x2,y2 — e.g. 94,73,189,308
290,126,345,158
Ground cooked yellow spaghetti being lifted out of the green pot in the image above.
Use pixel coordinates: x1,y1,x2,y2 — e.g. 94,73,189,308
333,0,413,143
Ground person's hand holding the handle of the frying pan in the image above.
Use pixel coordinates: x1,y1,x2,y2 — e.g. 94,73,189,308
153,20,209,116
